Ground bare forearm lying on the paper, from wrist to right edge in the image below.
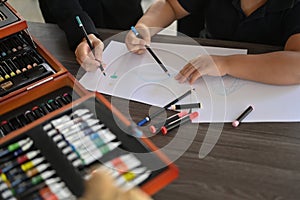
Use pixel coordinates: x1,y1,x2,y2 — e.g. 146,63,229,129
224,51,300,85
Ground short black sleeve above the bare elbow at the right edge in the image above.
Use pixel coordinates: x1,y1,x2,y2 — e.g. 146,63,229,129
283,1,300,41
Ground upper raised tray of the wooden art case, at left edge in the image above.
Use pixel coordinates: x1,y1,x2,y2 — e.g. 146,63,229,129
0,2,67,102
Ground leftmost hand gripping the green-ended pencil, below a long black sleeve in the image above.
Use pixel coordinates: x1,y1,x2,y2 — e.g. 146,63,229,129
75,34,104,71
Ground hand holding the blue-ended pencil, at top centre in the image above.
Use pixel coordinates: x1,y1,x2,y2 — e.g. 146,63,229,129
125,24,151,54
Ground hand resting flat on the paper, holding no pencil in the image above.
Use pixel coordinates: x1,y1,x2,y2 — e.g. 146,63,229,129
175,55,227,84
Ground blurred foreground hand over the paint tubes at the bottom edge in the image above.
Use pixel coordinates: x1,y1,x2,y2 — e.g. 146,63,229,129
82,169,151,200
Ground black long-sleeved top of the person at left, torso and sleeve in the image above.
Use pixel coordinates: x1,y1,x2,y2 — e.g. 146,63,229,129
39,0,143,50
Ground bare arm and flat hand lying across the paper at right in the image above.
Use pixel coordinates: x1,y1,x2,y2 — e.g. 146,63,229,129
176,33,300,85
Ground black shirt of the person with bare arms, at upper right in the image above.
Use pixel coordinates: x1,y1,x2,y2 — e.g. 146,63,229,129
179,0,300,46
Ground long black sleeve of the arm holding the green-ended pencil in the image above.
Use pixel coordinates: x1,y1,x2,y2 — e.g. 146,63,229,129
39,0,101,50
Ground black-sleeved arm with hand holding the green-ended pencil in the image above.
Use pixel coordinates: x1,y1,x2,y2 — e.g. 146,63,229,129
40,0,104,71
